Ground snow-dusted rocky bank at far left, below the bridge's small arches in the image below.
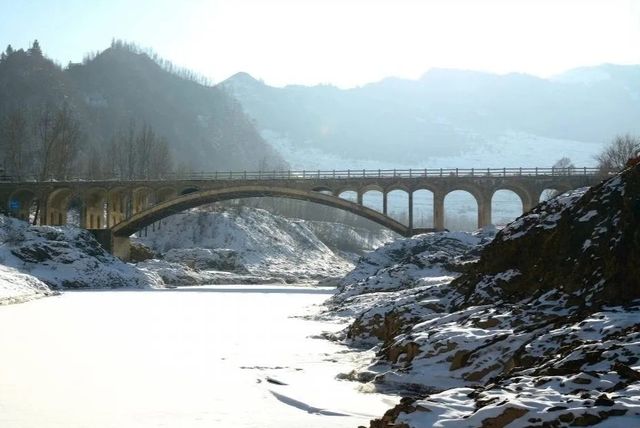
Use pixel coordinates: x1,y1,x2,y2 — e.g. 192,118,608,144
0,215,164,303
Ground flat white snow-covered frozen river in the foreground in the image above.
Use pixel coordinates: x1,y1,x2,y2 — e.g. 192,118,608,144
0,286,395,428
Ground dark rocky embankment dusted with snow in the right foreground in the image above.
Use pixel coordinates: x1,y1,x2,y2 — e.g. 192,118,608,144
336,167,640,427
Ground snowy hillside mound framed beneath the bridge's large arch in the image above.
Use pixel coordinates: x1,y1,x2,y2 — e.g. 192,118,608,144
137,207,352,282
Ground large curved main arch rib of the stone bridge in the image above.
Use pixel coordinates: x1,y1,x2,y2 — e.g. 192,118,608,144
112,185,411,238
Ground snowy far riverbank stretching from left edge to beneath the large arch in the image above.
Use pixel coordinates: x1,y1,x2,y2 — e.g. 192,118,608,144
0,207,389,304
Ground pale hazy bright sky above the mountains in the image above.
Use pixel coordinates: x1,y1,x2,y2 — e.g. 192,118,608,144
0,0,640,87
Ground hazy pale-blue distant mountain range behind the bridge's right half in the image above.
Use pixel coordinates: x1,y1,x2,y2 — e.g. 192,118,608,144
220,65,640,166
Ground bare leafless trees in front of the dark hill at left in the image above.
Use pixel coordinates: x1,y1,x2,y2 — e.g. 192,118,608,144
0,102,173,181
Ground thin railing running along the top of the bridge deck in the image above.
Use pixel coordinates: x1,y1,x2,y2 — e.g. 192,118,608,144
0,167,600,182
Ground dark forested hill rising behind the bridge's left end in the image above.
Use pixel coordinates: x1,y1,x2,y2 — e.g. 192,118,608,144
0,42,285,174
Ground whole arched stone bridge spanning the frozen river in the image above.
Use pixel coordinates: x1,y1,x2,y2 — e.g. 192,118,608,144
0,168,600,258
